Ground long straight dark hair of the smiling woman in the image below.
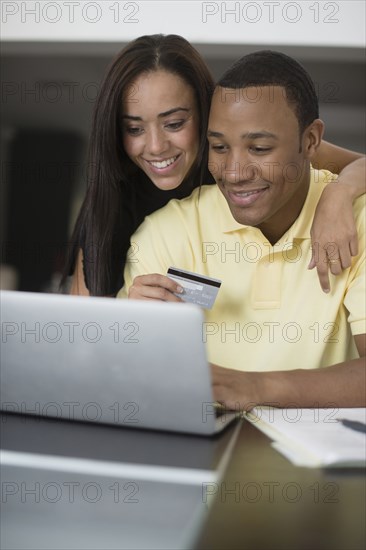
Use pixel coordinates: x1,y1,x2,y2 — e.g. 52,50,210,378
62,34,214,296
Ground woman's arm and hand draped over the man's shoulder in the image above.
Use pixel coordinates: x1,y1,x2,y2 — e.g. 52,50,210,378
309,141,366,292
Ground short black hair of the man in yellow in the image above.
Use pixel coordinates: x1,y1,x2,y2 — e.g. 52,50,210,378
217,50,319,135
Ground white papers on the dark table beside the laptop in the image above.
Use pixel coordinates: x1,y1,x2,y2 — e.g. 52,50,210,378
246,407,366,468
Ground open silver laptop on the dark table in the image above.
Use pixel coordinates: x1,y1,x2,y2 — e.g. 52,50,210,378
0,291,236,435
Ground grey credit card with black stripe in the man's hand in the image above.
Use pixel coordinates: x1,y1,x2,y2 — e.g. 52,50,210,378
167,267,221,309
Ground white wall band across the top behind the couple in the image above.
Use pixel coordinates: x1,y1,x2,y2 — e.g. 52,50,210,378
1,0,365,47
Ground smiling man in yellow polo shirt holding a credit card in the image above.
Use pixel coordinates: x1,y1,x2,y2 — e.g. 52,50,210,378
119,51,366,409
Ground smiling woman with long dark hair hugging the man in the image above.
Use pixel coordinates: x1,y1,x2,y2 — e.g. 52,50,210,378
63,35,363,302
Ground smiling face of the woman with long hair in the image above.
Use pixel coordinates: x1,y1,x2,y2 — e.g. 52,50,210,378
122,70,199,190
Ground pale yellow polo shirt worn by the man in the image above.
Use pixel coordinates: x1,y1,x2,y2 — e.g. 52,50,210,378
118,170,366,371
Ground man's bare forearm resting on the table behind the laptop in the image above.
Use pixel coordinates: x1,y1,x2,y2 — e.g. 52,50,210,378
211,334,366,410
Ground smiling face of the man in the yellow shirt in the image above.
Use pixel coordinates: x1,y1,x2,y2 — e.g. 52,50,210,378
208,86,318,242
